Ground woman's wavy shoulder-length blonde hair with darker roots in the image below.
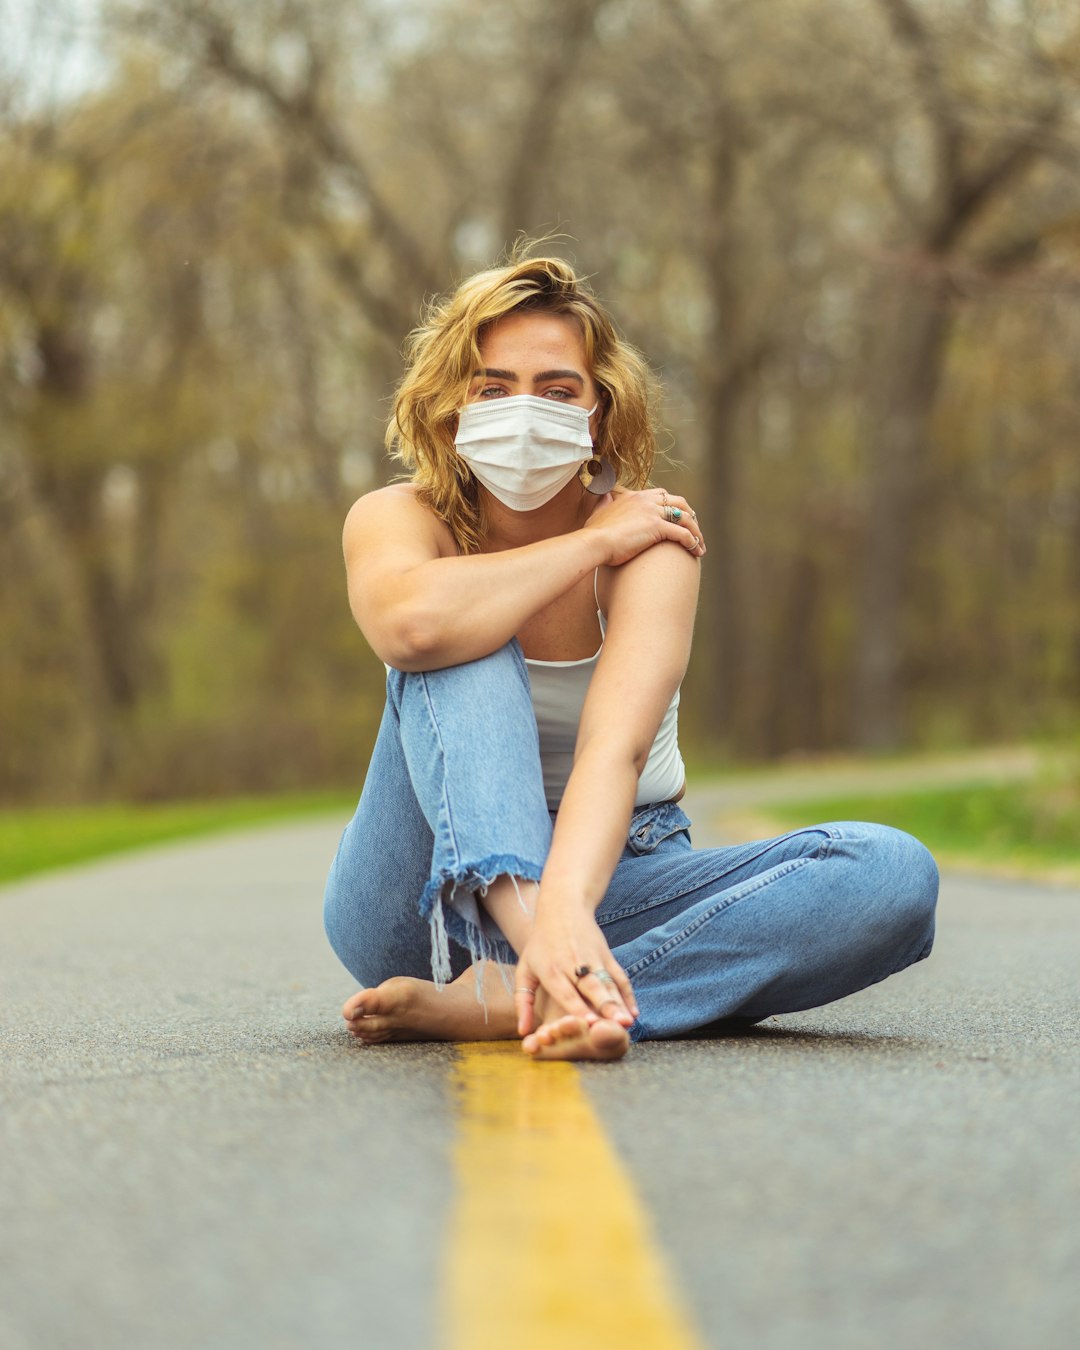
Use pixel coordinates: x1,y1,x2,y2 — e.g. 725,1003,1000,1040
386,246,659,554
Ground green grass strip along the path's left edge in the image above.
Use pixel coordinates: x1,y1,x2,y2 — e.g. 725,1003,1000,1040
0,792,355,882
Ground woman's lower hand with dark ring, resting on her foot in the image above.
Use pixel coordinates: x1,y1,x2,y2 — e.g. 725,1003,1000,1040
514,909,637,1035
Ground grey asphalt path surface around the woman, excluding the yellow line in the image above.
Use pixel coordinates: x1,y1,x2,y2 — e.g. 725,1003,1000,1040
0,797,1080,1350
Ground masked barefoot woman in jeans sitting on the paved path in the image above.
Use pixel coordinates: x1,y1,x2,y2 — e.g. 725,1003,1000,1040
325,248,937,1060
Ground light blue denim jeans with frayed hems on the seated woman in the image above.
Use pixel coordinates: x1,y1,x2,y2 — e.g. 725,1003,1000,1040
325,641,937,1040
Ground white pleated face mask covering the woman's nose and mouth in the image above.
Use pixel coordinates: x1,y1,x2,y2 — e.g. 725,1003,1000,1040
454,394,598,510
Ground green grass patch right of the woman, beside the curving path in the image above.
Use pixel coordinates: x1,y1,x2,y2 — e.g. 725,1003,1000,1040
765,779,1080,878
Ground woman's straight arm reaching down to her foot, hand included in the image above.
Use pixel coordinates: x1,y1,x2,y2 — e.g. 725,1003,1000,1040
514,543,699,1035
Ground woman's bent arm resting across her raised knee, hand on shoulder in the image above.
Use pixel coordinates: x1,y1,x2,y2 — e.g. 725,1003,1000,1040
343,486,693,671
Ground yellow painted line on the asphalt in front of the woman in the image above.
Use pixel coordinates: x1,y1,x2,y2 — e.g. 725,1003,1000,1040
443,1041,699,1350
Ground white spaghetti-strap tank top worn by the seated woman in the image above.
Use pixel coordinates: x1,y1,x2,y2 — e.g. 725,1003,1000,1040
525,578,686,811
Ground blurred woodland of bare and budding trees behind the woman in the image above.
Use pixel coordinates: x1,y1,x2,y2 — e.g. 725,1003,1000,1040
0,0,1080,805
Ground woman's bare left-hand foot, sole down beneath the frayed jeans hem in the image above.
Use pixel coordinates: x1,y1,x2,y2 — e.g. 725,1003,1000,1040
342,963,517,1045
